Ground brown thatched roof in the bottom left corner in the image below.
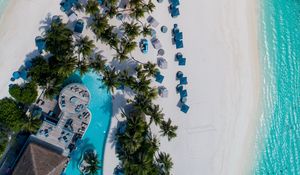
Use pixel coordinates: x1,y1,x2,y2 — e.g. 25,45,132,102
12,142,67,175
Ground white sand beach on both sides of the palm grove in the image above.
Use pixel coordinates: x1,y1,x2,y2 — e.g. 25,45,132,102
0,0,260,175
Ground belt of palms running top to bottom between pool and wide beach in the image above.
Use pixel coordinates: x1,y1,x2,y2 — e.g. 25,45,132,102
70,0,177,175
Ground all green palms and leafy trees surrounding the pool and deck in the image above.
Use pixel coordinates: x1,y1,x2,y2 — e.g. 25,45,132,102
0,0,177,172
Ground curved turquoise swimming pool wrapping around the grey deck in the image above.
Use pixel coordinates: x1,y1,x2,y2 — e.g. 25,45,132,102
63,72,112,175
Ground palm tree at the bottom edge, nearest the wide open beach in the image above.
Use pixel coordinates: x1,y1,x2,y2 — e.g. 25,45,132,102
156,152,173,175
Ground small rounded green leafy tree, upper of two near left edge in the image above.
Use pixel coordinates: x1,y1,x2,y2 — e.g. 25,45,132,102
9,81,38,105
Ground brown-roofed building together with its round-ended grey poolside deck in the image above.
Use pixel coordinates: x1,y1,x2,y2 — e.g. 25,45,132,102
13,83,91,175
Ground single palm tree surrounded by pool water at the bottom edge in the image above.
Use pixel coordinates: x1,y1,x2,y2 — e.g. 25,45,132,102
83,152,101,175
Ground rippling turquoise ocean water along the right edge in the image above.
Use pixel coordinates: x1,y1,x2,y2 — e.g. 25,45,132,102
253,0,300,175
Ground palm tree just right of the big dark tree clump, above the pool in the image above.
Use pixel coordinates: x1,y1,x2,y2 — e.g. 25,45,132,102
75,36,95,60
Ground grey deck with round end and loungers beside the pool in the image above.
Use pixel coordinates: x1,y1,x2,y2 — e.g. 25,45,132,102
36,84,91,156
